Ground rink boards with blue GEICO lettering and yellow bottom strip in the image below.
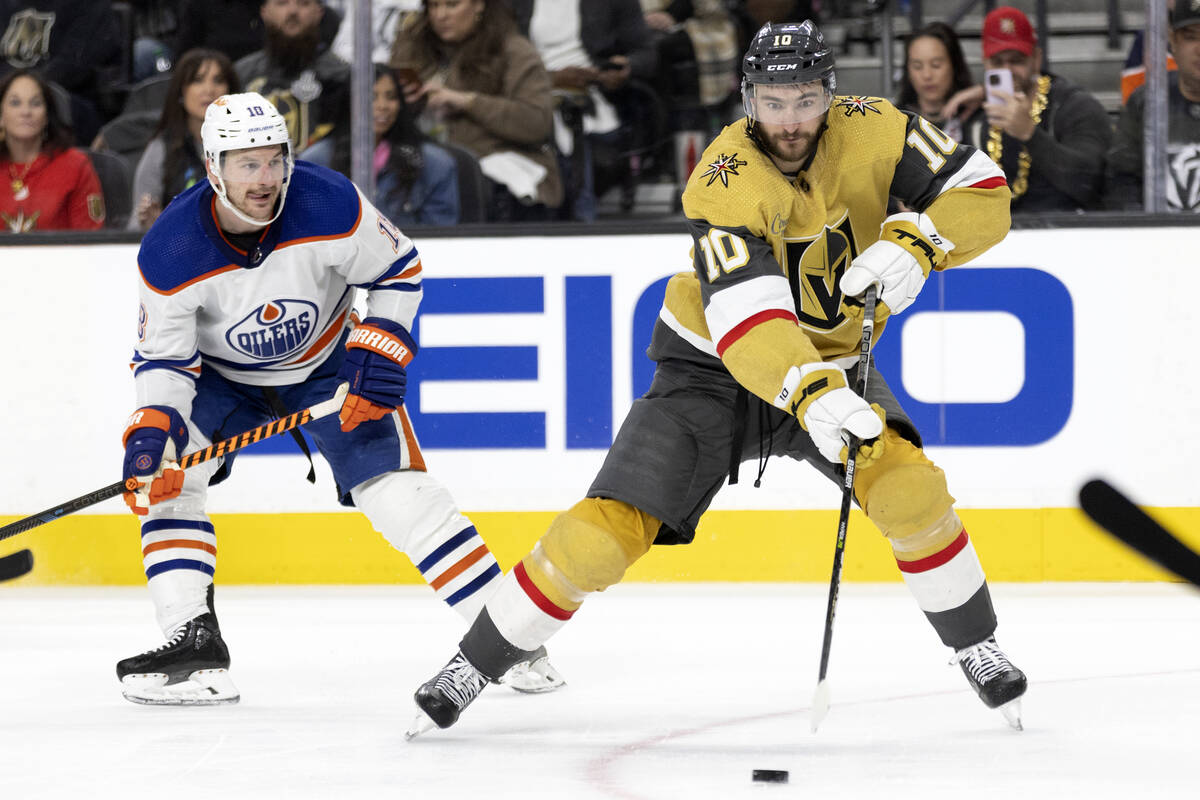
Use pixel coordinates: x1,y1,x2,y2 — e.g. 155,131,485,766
0,228,1200,584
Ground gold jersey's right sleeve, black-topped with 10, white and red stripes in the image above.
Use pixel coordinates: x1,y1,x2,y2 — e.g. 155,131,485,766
890,112,1012,270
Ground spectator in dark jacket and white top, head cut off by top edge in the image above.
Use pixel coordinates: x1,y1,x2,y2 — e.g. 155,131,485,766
512,0,658,222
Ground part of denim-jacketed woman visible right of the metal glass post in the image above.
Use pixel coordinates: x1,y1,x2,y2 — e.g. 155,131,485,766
371,64,458,228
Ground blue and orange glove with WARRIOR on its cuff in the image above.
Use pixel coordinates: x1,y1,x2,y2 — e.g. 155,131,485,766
337,317,416,433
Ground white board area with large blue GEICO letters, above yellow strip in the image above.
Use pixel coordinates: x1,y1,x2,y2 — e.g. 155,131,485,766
0,228,1200,515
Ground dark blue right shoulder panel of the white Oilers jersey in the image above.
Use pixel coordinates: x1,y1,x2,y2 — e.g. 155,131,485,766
277,161,362,241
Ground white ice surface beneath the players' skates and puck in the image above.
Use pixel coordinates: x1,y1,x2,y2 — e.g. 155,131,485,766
0,583,1200,800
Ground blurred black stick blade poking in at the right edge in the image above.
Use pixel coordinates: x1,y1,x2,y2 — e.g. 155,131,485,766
1079,479,1200,587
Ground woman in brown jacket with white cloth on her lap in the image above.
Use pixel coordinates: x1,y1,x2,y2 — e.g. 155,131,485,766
391,0,563,221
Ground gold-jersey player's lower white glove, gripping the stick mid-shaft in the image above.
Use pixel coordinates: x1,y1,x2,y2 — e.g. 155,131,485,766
775,361,884,468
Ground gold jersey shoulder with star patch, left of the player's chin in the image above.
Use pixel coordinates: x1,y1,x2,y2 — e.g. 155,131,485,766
683,119,794,235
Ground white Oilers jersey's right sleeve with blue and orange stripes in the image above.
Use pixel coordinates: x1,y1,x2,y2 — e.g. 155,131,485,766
338,192,422,332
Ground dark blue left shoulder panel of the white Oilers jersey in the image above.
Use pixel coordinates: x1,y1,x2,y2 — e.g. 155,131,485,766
138,181,229,294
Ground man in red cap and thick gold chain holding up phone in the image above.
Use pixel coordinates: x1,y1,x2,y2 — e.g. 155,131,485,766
964,6,1112,213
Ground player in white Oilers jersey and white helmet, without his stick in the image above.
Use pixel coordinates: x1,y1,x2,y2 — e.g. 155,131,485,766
116,92,562,705
